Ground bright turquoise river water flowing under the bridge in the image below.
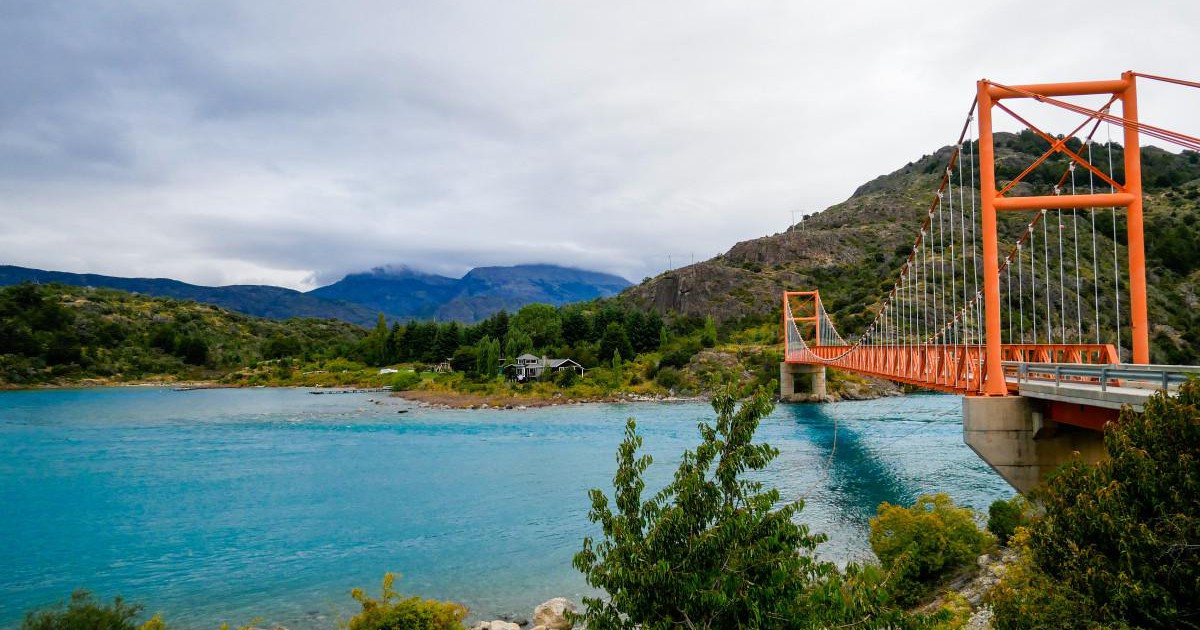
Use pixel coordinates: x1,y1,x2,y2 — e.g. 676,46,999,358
0,388,1012,630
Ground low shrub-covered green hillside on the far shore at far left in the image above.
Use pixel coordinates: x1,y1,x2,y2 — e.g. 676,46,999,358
0,283,366,385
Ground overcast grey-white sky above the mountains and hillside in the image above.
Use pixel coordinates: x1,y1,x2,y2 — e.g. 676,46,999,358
0,0,1200,289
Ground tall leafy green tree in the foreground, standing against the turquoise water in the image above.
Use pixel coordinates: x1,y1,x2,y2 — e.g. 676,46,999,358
574,391,864,630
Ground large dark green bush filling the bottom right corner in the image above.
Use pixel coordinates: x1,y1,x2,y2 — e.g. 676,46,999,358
994,380,1200,629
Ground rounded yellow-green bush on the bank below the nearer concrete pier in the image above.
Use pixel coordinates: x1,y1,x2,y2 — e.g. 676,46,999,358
870,493,991,604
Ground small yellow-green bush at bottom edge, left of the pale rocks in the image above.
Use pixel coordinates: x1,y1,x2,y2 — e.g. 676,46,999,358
346,574,468,630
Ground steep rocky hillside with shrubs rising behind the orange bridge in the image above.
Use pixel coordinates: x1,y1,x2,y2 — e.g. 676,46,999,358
622,132,1200,362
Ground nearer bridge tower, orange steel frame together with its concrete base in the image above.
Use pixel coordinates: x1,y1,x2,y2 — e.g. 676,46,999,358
962,72,1150,492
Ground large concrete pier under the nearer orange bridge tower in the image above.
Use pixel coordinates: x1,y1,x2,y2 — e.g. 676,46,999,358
964,396,1104,493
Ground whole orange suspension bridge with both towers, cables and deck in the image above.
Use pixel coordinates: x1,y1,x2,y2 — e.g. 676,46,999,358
782,72,1200,487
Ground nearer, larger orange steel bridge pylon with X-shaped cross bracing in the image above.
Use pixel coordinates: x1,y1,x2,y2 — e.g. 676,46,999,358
978,72,1150,396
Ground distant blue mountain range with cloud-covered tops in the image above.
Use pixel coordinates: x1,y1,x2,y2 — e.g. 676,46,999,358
0,265,630,325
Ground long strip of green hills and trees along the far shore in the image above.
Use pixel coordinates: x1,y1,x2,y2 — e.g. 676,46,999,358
0,283,862,400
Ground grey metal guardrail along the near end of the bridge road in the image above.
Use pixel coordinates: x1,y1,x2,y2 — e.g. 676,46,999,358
1004,361,1200,391
